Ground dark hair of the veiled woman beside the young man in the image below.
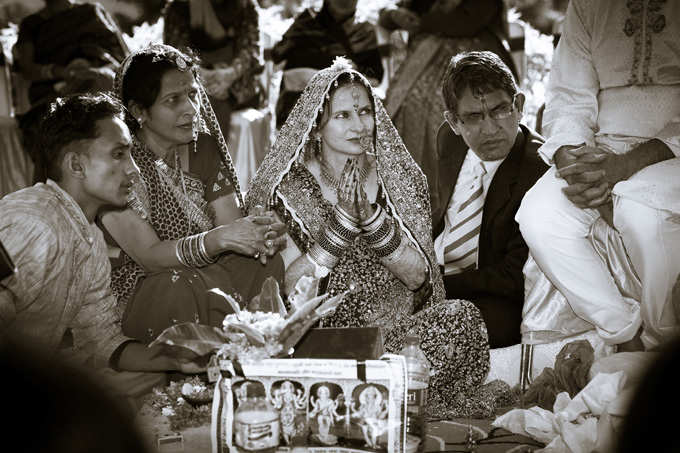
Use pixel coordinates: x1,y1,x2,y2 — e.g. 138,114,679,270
121,46,201,132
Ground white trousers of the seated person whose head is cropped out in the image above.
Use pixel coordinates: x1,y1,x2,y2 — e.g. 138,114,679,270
517,167,680,349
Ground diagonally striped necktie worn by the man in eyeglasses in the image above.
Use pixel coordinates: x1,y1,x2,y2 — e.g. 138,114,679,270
444,162,486,275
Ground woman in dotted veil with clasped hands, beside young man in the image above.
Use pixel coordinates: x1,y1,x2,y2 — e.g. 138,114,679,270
101,44,285,342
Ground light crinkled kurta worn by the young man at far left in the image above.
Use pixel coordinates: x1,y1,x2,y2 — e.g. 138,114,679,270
0,180,129,367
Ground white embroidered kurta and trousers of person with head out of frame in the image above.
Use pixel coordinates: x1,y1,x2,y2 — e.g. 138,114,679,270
518,0,680,348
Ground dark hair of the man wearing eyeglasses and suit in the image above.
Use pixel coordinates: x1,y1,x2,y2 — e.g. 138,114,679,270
442,51,518,113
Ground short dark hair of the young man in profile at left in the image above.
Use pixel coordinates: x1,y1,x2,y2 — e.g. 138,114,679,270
36,92,124,181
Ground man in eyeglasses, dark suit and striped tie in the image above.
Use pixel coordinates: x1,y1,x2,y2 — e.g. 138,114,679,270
428,52,548,348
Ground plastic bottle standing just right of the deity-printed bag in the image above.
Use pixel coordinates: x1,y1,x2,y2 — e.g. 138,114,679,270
400,334,430,453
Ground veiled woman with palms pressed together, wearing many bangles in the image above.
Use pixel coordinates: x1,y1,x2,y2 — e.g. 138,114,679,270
246,58,489,414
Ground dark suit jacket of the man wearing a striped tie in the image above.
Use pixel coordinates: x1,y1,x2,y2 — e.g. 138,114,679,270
432,122,548,304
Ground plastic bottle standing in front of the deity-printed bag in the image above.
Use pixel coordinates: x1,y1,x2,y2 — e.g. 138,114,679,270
234,384,280,453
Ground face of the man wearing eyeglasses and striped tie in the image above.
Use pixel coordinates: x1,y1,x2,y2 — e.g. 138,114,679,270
446,88,524,161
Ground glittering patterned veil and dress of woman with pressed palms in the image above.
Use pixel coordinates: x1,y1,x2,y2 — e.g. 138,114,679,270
246,57,489,413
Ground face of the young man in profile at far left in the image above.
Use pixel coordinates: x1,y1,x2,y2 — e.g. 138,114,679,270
79,117,139,207
